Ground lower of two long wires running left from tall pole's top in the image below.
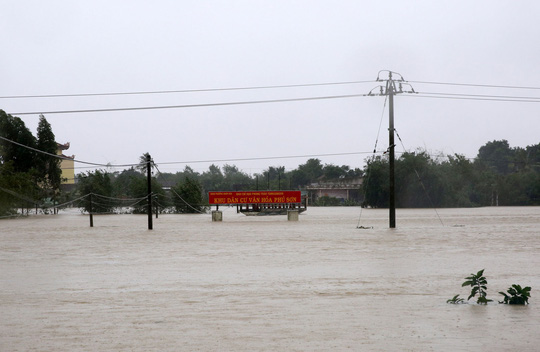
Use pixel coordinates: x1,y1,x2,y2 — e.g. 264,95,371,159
11,94,367,115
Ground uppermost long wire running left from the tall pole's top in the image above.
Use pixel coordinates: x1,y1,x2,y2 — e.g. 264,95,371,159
0,80,374,99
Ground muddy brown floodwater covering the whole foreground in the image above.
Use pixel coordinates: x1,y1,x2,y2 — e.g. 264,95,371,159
0,207,540,351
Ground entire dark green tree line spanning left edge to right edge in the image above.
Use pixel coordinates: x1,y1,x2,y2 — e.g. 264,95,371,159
0,110,540,215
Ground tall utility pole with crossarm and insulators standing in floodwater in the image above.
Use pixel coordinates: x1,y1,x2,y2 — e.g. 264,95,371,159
374,71,416,229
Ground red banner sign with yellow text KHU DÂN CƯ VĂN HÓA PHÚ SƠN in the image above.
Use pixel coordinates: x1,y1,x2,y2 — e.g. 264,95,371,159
208,191,302,204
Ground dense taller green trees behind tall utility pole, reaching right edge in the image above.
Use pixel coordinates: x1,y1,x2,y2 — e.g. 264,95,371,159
363,140,540,208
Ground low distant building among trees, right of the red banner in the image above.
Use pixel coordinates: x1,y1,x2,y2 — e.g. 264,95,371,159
306,178,363,202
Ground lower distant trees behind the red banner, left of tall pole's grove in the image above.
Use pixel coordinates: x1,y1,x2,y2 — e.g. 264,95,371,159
69,157,362,213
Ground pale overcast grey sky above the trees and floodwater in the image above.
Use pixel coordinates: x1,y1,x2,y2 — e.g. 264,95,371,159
0,0,540,173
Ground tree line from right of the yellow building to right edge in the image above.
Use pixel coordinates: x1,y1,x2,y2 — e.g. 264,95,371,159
65,140,540,213
